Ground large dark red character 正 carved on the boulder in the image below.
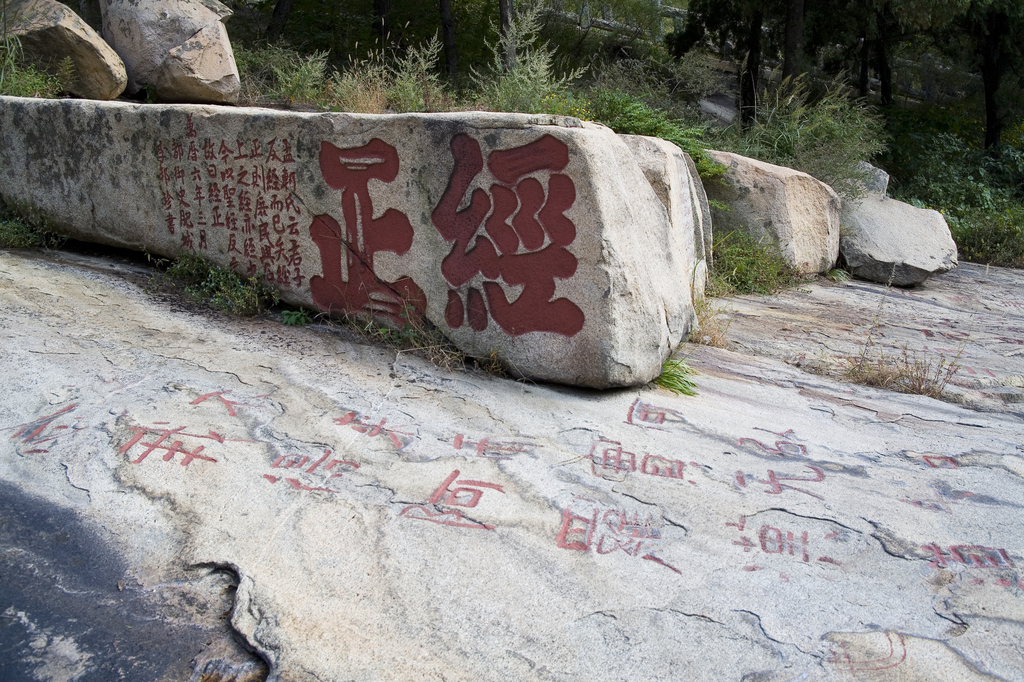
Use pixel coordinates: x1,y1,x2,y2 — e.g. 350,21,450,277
309,138,426,324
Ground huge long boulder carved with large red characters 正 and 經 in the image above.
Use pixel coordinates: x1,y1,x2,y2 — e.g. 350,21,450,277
0,98,694,388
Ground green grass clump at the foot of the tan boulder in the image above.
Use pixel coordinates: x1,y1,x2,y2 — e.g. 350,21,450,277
708,230,801,297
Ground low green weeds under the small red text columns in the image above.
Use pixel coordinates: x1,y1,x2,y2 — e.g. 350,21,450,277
151,254,279,316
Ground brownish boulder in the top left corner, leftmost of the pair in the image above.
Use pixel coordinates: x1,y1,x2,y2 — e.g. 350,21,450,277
8,0,127,99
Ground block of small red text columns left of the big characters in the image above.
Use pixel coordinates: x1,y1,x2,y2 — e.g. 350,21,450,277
156,114,306,288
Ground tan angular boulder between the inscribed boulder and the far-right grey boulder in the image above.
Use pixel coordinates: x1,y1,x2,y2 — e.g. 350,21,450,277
707,152,841,273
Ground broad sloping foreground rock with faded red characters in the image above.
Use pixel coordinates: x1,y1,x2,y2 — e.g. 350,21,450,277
0,245,1024,682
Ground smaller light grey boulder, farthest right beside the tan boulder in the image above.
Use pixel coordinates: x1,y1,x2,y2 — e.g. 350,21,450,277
840,195,956,287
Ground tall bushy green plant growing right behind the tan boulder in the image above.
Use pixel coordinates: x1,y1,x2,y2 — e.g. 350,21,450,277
715,78,886,198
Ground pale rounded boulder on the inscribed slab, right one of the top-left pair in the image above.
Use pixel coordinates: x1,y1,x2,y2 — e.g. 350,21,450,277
100,0,240,104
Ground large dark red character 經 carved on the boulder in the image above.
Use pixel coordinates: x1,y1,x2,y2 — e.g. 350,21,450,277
431,133,584,337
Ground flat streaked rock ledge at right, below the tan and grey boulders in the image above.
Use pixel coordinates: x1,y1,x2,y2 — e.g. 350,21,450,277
723,263,1024,416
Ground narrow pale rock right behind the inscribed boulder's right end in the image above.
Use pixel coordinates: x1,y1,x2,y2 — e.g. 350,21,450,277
622,135,711,300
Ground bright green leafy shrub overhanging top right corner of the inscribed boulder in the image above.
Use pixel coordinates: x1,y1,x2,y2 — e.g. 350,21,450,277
589,89,726,179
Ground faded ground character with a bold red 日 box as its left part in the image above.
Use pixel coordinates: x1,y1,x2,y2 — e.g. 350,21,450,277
555,497,680,573
